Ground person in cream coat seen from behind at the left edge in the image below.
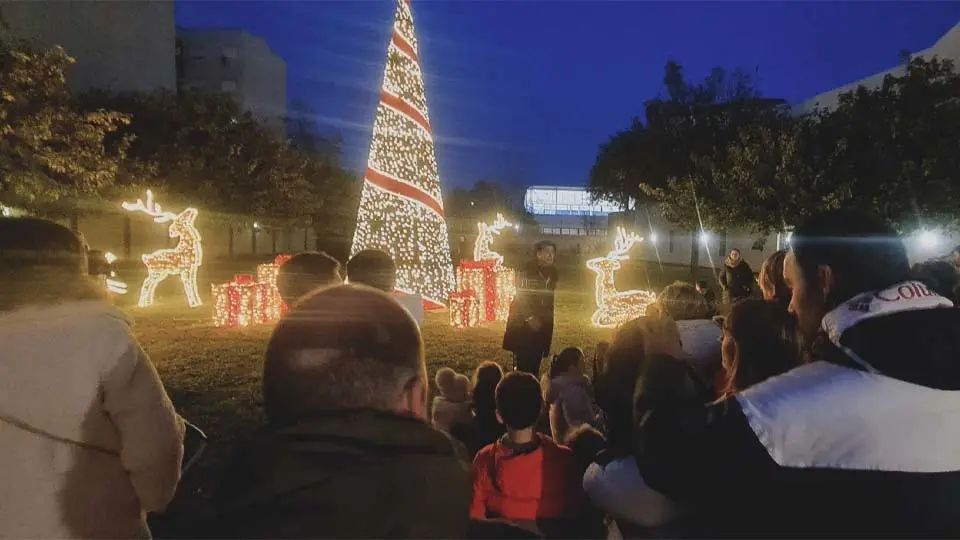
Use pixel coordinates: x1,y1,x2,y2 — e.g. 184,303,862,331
0,218,184,538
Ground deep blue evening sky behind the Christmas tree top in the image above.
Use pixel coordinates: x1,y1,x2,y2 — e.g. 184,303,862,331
177,0,960,188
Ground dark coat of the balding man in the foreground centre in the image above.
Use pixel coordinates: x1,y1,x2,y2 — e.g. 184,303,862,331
210,410,471,538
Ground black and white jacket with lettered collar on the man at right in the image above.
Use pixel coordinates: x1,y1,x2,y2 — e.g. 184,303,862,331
634,282,960,538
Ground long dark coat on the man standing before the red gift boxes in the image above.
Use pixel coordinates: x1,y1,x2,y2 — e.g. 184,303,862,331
503,260,558,358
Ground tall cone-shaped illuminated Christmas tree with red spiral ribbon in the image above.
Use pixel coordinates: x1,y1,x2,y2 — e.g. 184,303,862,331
352,0,454,307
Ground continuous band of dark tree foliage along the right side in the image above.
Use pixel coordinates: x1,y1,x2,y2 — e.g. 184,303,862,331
591,58,960,232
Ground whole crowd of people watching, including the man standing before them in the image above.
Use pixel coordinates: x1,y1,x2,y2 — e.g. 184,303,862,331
0,211,960,538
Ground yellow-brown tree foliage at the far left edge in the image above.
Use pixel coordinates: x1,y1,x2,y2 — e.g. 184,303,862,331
0,40,130,205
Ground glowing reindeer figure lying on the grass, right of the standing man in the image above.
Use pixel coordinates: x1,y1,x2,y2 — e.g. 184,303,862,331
587,227,657,328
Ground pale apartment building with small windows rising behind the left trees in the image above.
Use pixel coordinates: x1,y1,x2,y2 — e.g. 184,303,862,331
176,28,287,129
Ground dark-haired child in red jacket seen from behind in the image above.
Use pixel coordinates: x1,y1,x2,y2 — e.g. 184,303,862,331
470,372,583,533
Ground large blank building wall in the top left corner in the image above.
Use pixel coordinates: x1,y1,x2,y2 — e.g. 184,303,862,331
0,0,176,91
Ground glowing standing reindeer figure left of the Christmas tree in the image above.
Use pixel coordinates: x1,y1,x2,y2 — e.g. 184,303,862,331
123,190,203,307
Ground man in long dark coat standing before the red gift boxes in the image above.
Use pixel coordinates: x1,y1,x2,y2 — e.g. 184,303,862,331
503,240,557,377
